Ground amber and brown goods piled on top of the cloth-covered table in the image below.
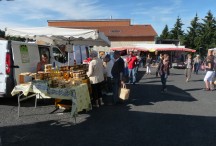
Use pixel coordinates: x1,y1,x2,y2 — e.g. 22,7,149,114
19,64,89,89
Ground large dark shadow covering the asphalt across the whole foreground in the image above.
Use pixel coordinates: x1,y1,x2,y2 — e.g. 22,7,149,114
0,105,216,146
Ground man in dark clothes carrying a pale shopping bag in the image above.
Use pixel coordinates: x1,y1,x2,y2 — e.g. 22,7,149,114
111,51,124,104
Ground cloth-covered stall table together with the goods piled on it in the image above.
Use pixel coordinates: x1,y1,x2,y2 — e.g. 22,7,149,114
11,64,91,116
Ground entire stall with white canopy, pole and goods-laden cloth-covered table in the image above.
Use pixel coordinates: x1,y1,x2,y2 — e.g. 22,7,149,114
5,27,110,118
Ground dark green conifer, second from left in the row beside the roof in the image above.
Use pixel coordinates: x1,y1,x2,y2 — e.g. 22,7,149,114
170,16,184,42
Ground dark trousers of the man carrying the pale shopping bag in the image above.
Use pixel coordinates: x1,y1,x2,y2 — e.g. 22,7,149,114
113,78,120,104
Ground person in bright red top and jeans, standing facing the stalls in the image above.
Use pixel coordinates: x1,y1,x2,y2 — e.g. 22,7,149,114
126,51,137,84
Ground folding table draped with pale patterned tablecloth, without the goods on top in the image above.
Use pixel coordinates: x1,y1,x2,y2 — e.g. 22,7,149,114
11,80,92,116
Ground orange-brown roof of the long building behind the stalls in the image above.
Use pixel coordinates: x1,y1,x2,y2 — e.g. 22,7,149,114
47,19,157,37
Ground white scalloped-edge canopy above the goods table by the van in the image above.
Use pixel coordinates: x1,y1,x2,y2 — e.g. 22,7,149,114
5,27,110,46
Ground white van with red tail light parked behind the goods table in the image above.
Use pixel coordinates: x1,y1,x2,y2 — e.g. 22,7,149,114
0,40,67,97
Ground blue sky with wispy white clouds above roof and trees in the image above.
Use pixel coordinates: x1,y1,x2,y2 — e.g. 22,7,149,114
0,0,216,35
